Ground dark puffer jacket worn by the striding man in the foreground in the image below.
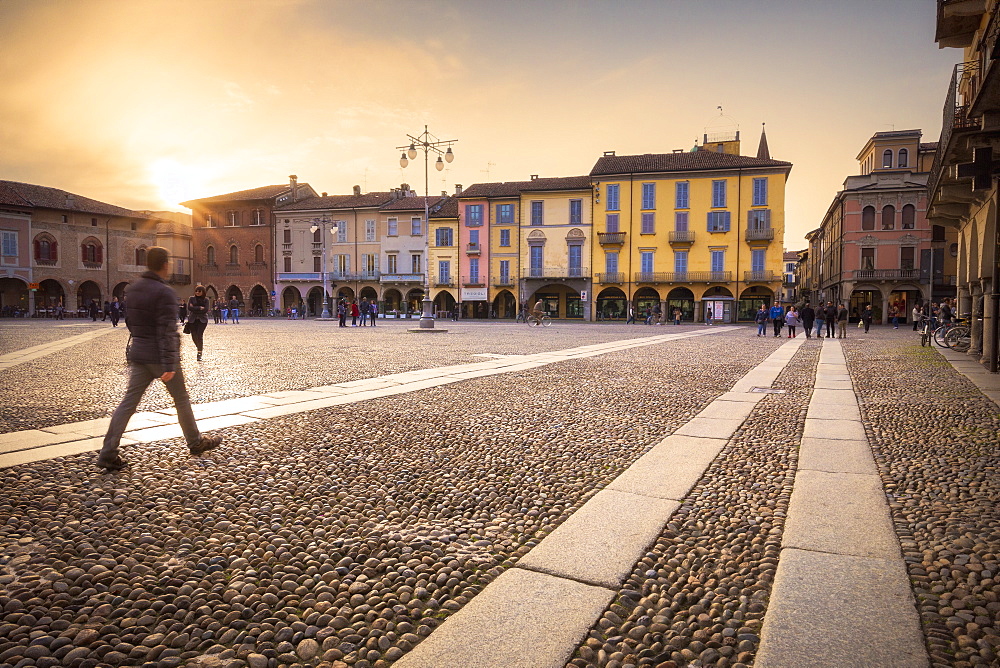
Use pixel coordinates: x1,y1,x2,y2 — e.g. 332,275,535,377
125,271,180,373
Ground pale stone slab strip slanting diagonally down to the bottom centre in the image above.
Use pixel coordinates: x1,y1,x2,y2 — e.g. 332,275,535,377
394,339,804,668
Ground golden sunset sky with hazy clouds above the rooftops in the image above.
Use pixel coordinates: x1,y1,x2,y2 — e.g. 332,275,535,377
0,0,962,245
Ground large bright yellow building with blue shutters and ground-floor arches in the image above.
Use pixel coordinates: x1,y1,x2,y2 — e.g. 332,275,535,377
590,131,792,322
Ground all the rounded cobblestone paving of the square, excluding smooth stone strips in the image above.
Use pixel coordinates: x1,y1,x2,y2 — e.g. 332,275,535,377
0,321,1000,668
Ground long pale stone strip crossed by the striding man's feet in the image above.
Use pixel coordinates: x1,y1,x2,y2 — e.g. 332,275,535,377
0,327,733,468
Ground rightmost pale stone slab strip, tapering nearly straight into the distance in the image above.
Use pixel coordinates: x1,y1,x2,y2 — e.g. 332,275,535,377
754,341,928,668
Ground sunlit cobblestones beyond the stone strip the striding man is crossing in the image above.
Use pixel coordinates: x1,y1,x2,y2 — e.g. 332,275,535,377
0,318,694,433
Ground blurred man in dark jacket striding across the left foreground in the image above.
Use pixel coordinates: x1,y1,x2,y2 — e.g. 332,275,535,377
97,246,222,473
